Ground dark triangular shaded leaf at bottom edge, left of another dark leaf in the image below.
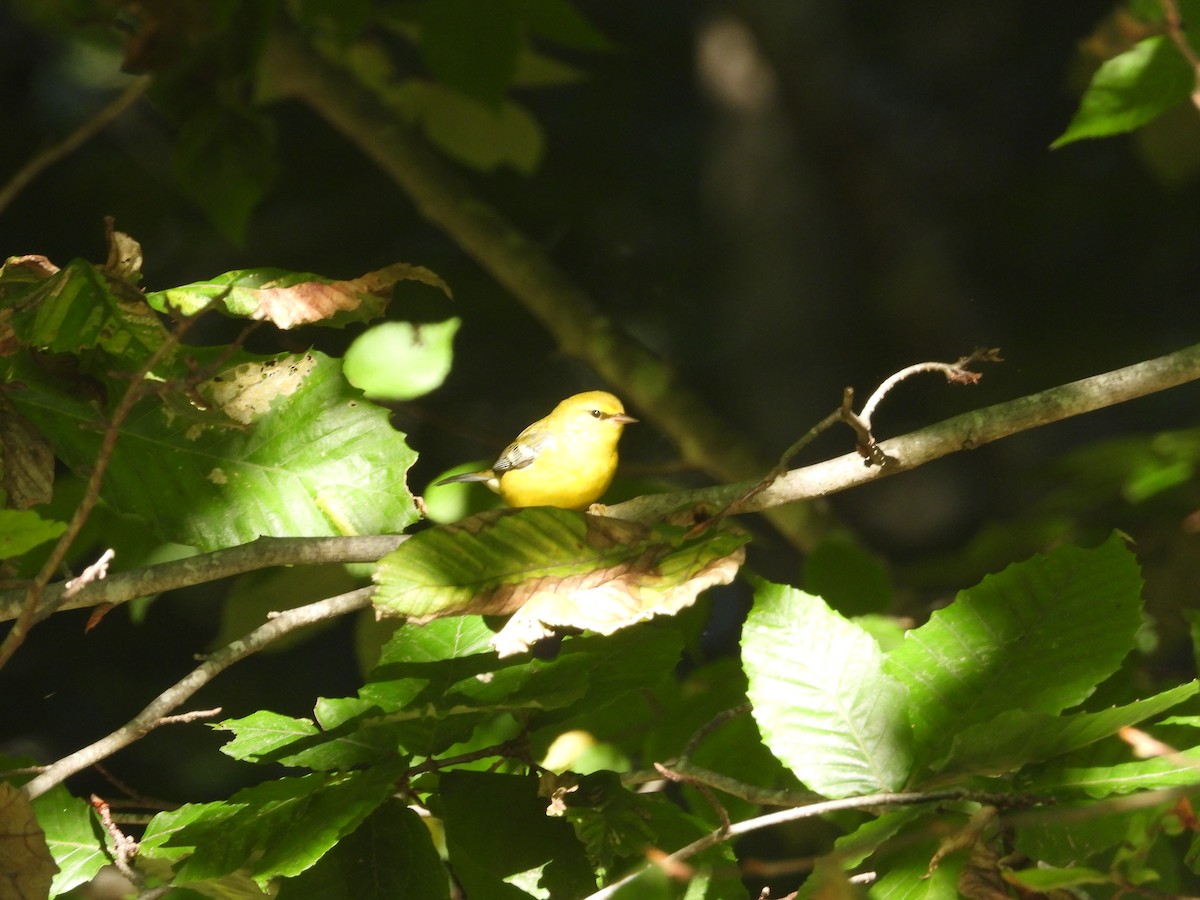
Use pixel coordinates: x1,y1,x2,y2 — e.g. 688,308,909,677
278,799,450,900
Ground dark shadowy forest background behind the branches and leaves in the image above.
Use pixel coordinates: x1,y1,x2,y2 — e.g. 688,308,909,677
0,0,1200,799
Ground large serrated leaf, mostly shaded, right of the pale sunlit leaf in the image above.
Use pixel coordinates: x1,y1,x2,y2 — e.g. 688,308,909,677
887,535,1141,764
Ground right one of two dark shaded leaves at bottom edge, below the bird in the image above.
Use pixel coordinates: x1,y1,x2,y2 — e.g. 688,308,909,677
436,770,596,898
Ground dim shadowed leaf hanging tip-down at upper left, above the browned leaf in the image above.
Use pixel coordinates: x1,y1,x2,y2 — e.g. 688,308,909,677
172,107,276,245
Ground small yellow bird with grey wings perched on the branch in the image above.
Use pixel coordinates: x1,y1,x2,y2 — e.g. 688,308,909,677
438,391,637,510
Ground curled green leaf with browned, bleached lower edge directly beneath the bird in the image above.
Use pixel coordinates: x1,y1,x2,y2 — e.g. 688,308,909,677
374,508,746,656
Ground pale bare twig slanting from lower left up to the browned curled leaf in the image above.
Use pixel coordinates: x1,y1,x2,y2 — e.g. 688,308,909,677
24,587,374,798
